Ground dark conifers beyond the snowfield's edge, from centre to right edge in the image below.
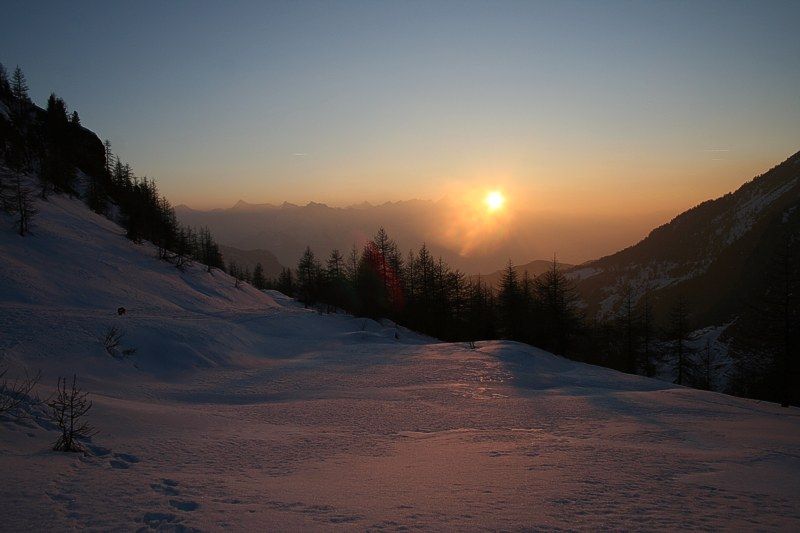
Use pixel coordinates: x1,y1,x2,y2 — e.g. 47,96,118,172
230,222,800,404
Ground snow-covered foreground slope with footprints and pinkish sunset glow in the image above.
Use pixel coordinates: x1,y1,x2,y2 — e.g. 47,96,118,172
0,184,800,531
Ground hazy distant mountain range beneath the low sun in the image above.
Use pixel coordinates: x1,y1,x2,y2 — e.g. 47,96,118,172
175,198,668,274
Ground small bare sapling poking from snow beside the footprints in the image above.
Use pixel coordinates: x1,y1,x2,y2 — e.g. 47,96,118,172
48,374,96,452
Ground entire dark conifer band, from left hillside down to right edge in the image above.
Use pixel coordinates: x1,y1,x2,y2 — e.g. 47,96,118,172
0,65,800,405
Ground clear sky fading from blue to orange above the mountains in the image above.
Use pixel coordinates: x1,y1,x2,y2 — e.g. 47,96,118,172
0,0,800,216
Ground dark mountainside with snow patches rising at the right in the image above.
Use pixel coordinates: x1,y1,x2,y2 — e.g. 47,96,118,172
570,148,800,325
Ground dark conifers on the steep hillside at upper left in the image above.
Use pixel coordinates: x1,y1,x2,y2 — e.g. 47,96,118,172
0,64,224,272
